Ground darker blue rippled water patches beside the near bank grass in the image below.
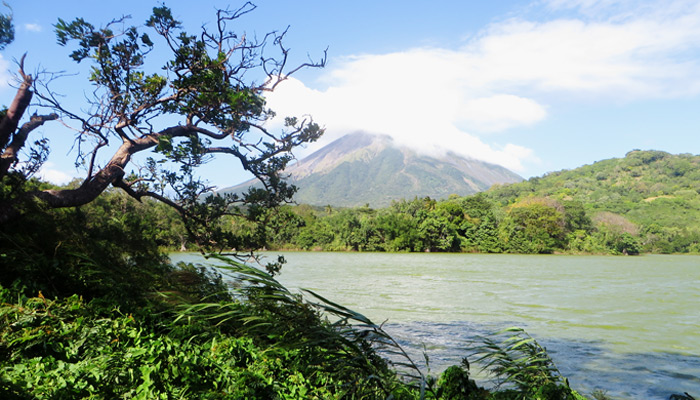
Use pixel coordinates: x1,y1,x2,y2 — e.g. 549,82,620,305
385,321,700,400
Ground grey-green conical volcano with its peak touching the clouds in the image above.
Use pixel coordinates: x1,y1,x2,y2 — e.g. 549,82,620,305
222,133,522,208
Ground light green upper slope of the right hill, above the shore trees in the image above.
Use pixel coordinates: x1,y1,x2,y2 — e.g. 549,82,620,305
488,150,700,244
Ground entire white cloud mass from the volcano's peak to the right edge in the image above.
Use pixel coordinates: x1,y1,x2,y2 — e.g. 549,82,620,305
268,0,700,171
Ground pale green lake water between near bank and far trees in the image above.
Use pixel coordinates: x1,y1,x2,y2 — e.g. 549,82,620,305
172,252,700,399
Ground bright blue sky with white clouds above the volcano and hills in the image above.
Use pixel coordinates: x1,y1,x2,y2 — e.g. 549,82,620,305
0,0,700,187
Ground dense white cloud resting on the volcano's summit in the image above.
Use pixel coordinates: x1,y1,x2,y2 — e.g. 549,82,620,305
268,49,546,170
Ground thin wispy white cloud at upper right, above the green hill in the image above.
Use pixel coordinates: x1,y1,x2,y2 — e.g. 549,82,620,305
462,6,700,100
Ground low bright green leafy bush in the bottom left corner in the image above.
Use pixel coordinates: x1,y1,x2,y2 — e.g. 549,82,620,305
0,290,350,399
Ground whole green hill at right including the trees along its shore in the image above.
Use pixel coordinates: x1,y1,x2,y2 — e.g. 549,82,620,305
262,151,700,254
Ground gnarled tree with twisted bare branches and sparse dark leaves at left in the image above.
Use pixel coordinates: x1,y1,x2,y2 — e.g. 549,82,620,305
0,3,325,252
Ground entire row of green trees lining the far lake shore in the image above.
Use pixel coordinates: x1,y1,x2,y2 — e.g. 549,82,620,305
86,170,700,255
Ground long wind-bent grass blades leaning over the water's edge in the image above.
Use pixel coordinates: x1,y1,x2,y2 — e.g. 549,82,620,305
175,255,434,398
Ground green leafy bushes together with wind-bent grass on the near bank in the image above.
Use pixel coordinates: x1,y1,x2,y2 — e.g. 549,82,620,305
0,261,416,399
